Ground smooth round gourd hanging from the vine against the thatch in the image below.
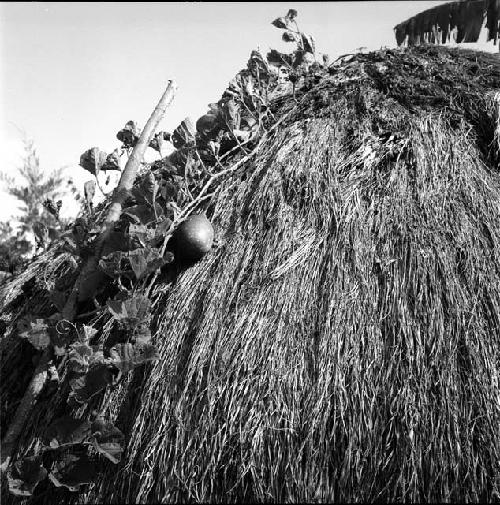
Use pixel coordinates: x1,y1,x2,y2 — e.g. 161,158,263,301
174,214,214,262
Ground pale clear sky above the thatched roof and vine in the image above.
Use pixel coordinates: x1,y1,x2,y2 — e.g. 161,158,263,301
0,0,498,224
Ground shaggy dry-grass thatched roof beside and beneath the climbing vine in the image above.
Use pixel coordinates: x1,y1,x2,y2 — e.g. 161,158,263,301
0,47,500,504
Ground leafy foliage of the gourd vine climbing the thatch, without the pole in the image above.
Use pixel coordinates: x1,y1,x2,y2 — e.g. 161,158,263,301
5,9,326,496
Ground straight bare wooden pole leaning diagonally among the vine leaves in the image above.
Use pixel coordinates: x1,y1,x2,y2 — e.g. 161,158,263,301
0,80,177,473
